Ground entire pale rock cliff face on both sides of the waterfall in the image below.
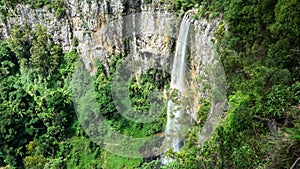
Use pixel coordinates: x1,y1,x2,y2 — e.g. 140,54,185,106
0,0,225,145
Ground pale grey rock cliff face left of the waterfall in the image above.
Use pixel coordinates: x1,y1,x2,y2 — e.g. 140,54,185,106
0,0,177,71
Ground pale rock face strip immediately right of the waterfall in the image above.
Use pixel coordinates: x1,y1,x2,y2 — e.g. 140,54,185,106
190,18,221,121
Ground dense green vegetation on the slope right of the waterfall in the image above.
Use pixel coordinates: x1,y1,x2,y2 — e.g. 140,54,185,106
162,0,300,168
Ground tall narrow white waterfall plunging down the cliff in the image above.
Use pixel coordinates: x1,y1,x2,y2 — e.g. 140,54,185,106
165,15,191,152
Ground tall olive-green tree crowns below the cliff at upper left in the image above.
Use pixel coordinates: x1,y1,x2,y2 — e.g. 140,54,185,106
9,24,62,80
